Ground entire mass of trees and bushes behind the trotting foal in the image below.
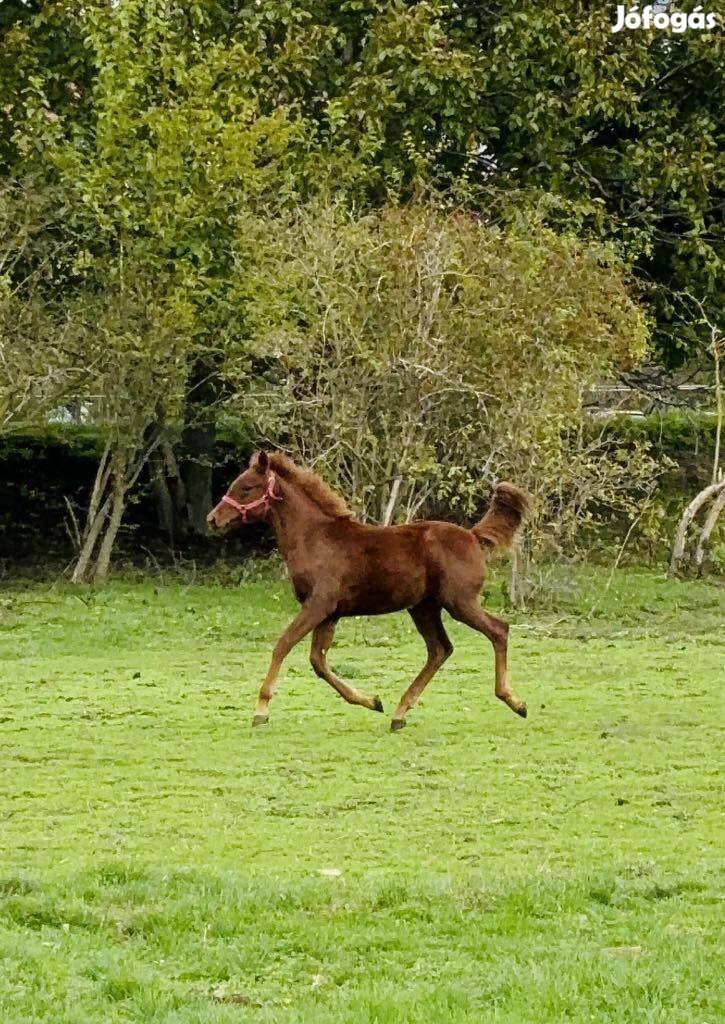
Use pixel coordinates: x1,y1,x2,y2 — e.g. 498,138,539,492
0,0,722,580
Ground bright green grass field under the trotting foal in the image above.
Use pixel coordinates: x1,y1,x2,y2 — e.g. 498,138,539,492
0,571,725,1024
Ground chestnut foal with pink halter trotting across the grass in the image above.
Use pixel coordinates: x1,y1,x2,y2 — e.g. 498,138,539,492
207,452,529,731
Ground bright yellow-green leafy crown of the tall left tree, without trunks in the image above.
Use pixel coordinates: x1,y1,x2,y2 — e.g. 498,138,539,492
3,0,313,349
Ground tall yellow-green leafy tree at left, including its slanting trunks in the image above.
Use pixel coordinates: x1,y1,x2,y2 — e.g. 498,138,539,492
2,0,313,577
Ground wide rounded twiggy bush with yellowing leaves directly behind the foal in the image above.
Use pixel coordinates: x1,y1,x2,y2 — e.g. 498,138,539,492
249,198,653,544
